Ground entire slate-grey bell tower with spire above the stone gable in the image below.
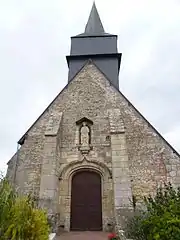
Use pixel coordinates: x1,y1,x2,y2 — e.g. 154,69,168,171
66,2,121,89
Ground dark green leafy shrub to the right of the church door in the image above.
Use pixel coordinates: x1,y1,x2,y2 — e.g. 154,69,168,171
128,183,180,240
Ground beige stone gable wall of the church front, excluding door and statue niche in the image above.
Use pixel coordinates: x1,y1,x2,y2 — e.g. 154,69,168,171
8,62,180,232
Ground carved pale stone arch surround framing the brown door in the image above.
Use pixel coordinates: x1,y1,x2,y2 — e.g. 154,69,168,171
59,157,113,231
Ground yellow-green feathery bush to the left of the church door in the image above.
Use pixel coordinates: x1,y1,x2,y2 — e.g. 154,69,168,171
0,179,49,240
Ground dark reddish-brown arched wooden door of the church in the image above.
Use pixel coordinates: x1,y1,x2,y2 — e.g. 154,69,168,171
70,171,102,231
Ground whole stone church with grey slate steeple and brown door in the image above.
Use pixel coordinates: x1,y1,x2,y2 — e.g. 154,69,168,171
7,4,180,234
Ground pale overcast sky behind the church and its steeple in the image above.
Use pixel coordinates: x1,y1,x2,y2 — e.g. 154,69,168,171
0,0,180,171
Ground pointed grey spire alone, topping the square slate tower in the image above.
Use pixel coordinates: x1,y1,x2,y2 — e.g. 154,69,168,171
84,2,105,35
